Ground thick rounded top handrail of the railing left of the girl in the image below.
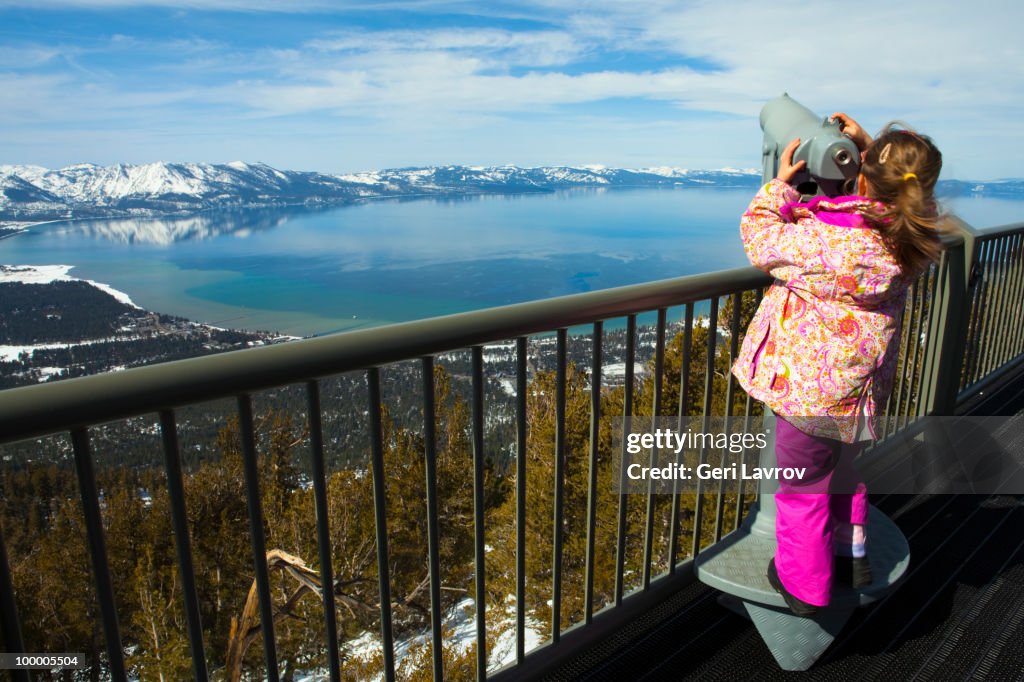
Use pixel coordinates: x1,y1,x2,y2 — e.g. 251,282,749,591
0,267,772,443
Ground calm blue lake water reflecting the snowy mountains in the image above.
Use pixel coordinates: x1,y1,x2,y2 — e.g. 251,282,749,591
0,189,1024,335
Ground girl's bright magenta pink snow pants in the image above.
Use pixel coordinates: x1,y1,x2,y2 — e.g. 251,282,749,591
775,416,867,606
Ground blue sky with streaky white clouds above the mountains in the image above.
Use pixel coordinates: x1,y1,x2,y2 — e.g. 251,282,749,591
0,0,1024,180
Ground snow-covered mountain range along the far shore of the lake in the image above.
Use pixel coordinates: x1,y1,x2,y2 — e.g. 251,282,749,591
0,162,758,220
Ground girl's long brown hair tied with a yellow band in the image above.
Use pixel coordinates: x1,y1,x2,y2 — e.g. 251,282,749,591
860,124,946,274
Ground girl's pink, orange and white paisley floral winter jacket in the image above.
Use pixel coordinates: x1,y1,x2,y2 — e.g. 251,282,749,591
732,180,910,442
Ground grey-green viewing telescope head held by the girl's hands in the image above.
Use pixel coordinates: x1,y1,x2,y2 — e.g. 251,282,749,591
761,93,860,197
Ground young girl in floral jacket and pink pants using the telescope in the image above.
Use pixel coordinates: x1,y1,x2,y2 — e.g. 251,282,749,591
732,113,942,615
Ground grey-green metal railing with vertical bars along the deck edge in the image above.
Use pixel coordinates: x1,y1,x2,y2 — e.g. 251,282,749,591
0,218,1024,680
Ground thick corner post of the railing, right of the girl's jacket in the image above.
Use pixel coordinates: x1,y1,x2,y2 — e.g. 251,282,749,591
923,218,975,415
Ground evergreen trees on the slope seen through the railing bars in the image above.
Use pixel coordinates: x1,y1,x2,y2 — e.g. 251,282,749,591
0,294,757,680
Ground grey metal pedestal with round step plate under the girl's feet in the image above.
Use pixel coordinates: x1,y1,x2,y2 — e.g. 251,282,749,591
693,413,910,671
